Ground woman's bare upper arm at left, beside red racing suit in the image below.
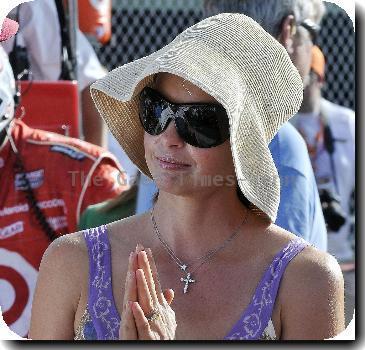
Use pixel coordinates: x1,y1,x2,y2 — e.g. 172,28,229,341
29,233,88,340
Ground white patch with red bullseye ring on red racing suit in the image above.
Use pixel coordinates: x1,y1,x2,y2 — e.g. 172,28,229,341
0,248,38,337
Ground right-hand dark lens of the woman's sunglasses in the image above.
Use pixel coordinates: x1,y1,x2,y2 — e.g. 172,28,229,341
175,106,229,148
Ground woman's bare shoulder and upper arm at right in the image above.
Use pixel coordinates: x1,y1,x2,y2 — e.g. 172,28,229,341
280,247,344,340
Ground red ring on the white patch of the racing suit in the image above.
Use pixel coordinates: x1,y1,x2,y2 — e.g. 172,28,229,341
0,266,29,326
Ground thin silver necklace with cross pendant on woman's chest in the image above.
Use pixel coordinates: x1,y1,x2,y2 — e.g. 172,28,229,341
150,208,248,294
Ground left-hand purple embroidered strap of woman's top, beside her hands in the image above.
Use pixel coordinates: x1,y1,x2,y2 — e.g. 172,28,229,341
84,225,120,340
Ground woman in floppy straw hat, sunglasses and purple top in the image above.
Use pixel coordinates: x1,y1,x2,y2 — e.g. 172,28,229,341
30,14,343,340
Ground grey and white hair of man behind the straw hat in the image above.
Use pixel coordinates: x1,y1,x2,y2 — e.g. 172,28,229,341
203,0,325,38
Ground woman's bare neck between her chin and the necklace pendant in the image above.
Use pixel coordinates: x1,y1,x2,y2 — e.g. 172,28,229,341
150,191,248,259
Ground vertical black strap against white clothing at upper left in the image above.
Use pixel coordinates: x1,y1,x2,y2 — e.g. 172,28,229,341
55,0,76,80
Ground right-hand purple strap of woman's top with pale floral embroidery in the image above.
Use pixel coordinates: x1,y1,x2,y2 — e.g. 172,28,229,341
225,237,309,340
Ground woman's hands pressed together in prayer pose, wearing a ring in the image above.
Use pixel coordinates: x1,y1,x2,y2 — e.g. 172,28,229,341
119,245,176,340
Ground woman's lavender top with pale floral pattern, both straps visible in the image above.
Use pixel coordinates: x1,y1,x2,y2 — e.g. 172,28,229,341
75,226,309,340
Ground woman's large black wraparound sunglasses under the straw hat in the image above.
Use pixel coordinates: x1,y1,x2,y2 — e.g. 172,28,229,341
139,87,229,148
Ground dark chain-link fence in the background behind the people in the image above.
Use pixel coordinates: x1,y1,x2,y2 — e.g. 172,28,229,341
89,0,355,109
